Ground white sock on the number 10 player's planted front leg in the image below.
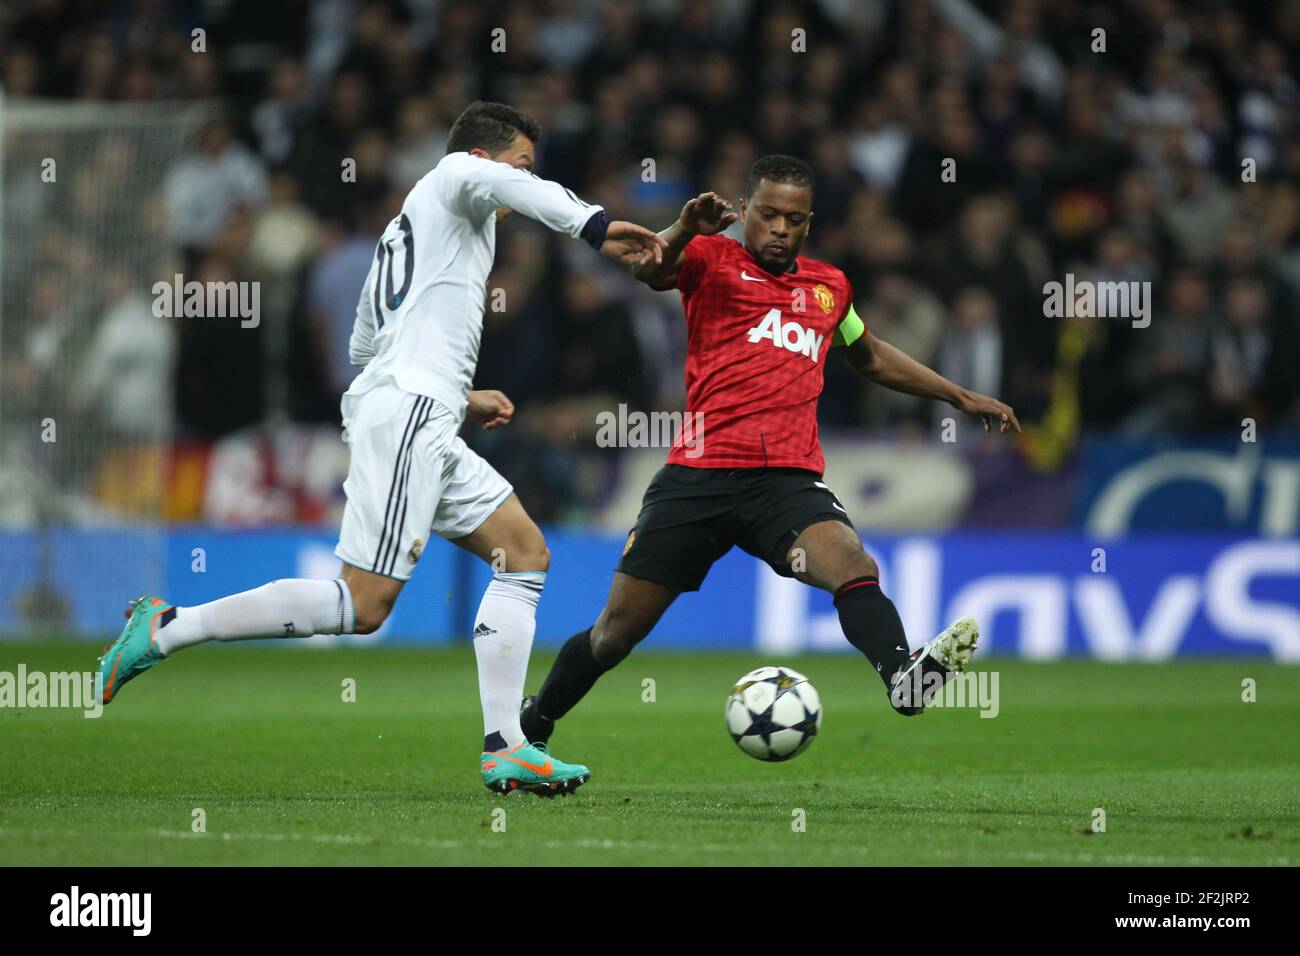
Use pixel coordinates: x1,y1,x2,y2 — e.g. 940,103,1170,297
475,571,546,750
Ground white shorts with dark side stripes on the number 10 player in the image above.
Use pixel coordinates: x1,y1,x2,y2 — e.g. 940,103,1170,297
334,385,514,581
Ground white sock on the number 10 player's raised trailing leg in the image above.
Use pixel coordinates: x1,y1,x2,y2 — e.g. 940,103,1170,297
155,578,356,656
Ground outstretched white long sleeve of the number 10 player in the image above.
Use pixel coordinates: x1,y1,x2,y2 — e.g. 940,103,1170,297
443,153,603,239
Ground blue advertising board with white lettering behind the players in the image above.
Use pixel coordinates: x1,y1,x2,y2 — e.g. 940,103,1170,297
0,528,1300,662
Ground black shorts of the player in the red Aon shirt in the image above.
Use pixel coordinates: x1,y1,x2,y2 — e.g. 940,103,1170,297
618,464,853,591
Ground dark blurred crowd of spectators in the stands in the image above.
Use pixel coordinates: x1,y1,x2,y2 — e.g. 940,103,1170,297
0,0,1300,520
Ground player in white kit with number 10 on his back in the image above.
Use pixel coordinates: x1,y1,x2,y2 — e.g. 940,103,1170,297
100,103,664,796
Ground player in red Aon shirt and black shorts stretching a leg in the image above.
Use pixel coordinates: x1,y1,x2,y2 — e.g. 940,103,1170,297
521,155,1021,741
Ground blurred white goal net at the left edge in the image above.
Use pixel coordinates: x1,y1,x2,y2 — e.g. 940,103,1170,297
0,94,207,636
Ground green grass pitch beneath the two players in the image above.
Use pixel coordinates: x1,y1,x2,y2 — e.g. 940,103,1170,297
0,641,1300,866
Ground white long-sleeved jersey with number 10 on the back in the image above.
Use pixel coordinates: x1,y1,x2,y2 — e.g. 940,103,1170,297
347,152,602,419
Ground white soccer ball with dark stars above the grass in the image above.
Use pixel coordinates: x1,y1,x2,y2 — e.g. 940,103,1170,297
727,667,822,761
